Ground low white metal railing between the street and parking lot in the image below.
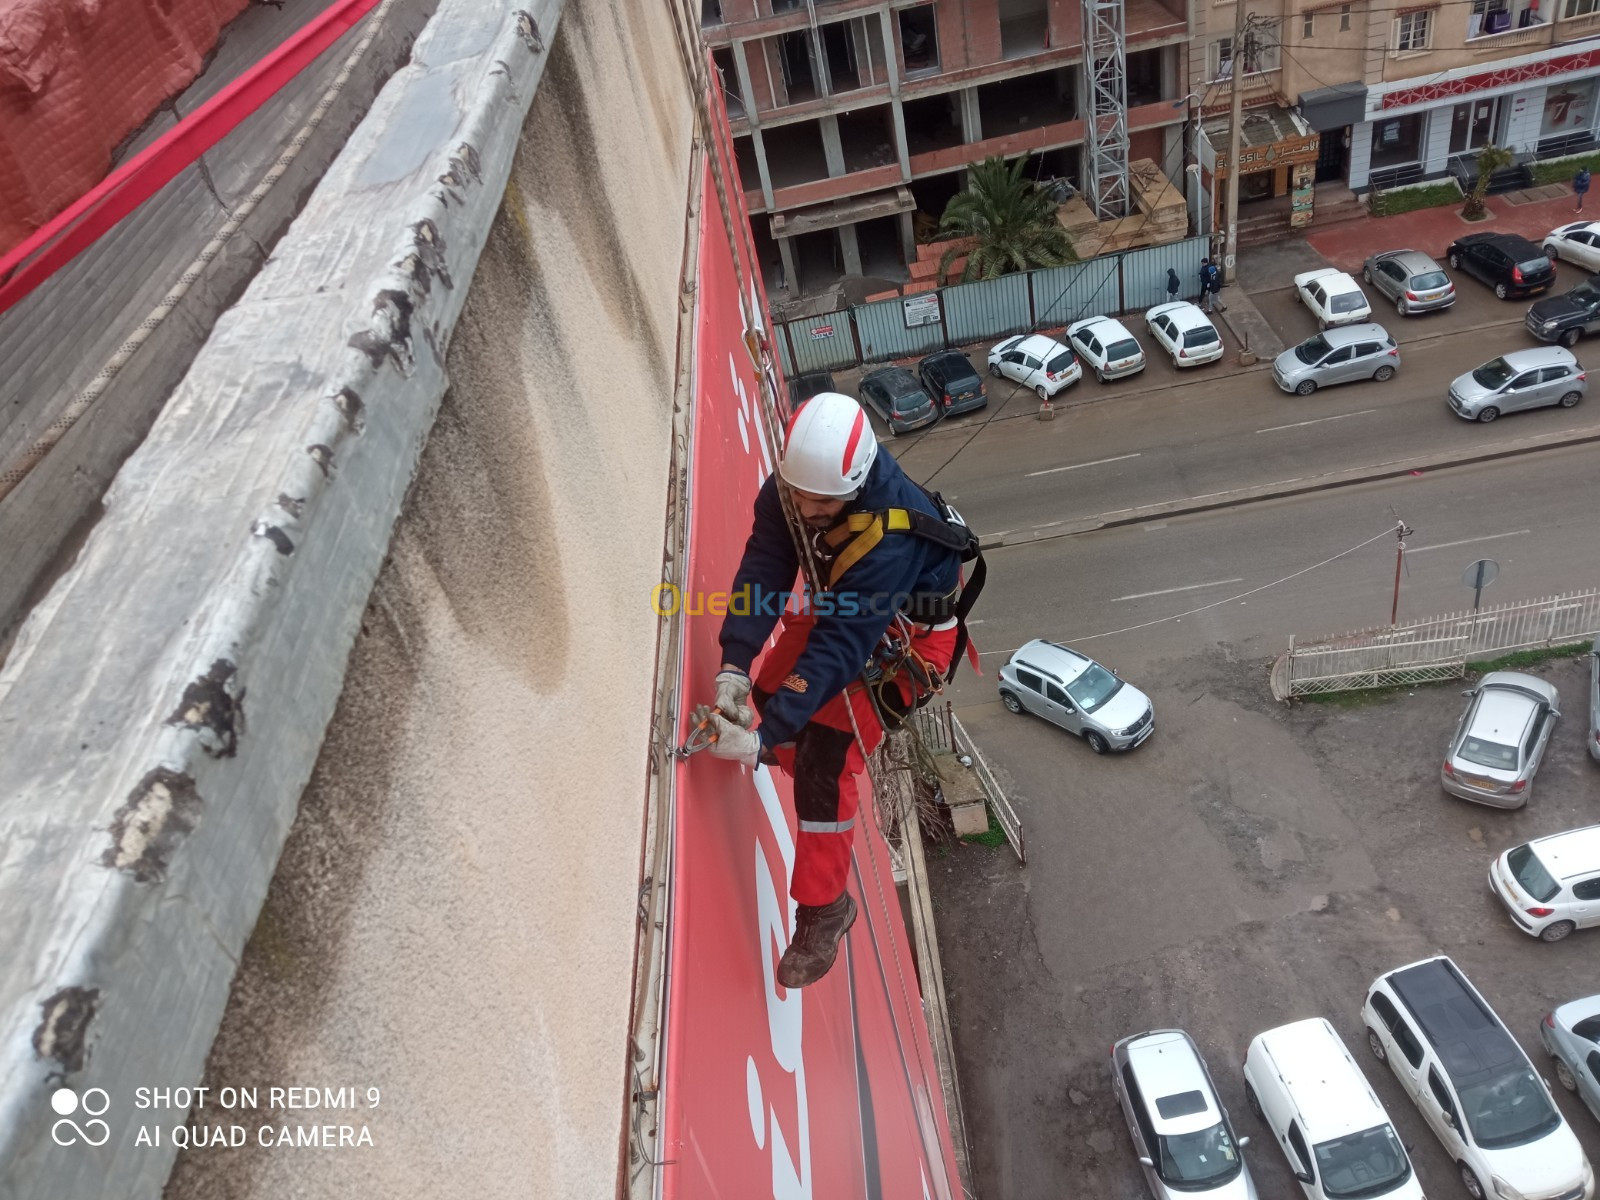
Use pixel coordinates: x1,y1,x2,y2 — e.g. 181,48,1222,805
1272,587,1600,701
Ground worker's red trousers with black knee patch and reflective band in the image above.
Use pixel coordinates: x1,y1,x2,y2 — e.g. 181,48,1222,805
752,613,955,907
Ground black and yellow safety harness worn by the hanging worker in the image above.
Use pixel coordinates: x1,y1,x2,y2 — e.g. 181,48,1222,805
818,488,989,717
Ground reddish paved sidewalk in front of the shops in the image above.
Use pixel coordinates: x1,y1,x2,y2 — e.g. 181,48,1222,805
1285,184,1600,272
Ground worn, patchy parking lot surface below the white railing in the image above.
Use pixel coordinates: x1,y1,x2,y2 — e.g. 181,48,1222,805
930,653,1600,1200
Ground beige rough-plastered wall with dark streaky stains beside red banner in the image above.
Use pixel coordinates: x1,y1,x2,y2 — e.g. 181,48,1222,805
166,0,691,1200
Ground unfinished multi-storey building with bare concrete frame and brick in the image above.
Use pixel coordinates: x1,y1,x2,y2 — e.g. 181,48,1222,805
701,0,1194,294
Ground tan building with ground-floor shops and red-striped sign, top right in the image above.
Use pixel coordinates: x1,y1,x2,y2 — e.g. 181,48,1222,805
1192,0,1600,214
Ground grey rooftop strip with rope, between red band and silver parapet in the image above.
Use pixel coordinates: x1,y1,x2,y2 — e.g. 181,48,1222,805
0,0,435,656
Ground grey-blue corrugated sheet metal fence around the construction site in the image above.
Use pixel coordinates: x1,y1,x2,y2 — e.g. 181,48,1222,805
774,237,1210,374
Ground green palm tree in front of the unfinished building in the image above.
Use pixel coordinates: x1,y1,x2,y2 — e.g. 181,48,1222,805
939,157,1077,282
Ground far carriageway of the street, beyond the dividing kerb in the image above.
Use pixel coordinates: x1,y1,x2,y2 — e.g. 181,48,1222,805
888,267,1600,538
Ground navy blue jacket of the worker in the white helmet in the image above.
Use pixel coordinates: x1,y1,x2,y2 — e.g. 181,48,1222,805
722,453,960,749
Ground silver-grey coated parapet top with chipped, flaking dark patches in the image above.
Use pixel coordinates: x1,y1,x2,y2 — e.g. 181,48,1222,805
0,0,569,1200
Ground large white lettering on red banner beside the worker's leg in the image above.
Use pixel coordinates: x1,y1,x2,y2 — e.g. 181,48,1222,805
746,766,811,1200
